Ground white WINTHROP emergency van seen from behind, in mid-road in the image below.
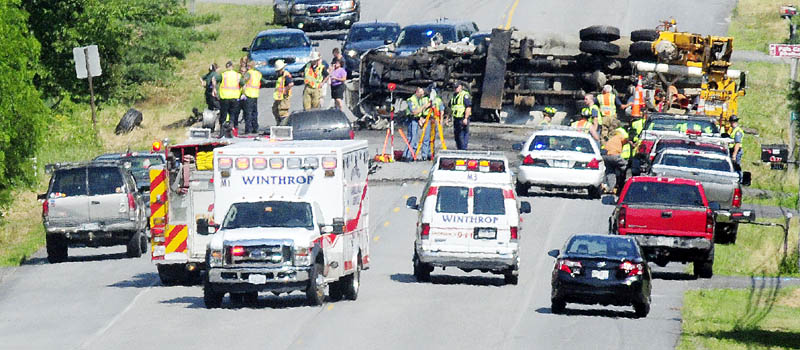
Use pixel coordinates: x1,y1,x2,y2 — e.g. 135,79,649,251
406,151,531,284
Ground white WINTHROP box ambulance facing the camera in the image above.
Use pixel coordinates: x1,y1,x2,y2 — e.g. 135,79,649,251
203,140,370,308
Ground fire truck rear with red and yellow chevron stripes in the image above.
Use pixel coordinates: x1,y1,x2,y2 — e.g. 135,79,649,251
150,129,239,285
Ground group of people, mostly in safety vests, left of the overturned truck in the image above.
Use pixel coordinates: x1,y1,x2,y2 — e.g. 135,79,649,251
201,48,347,134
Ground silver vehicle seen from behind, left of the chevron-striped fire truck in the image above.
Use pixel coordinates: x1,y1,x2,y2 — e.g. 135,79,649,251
38,162,147,263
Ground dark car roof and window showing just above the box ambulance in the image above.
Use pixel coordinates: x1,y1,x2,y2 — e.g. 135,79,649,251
281,108,355,140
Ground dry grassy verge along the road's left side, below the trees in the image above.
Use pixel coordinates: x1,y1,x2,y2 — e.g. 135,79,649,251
0,3,272,266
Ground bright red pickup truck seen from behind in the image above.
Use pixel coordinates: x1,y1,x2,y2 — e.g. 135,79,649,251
609,176,715,278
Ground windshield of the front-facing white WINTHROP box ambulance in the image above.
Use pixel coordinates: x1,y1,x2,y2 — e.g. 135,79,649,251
222,201,314,230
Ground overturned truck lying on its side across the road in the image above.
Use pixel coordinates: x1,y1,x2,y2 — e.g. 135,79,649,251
350,26,743,127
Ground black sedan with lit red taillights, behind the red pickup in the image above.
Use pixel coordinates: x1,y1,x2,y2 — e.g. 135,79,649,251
547,234,651,317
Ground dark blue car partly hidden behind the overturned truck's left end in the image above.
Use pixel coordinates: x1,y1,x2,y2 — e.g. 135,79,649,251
342,21,400,77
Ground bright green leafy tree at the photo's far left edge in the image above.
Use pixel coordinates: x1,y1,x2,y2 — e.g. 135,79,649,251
0,0,47,203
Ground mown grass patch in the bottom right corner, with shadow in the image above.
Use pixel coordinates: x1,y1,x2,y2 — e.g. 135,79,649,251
677,283,800,350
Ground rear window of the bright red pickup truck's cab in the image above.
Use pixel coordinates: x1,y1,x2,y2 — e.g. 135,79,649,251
622,182,705,206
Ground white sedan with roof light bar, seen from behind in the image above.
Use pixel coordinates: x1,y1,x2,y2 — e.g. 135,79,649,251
516,129,606,198
